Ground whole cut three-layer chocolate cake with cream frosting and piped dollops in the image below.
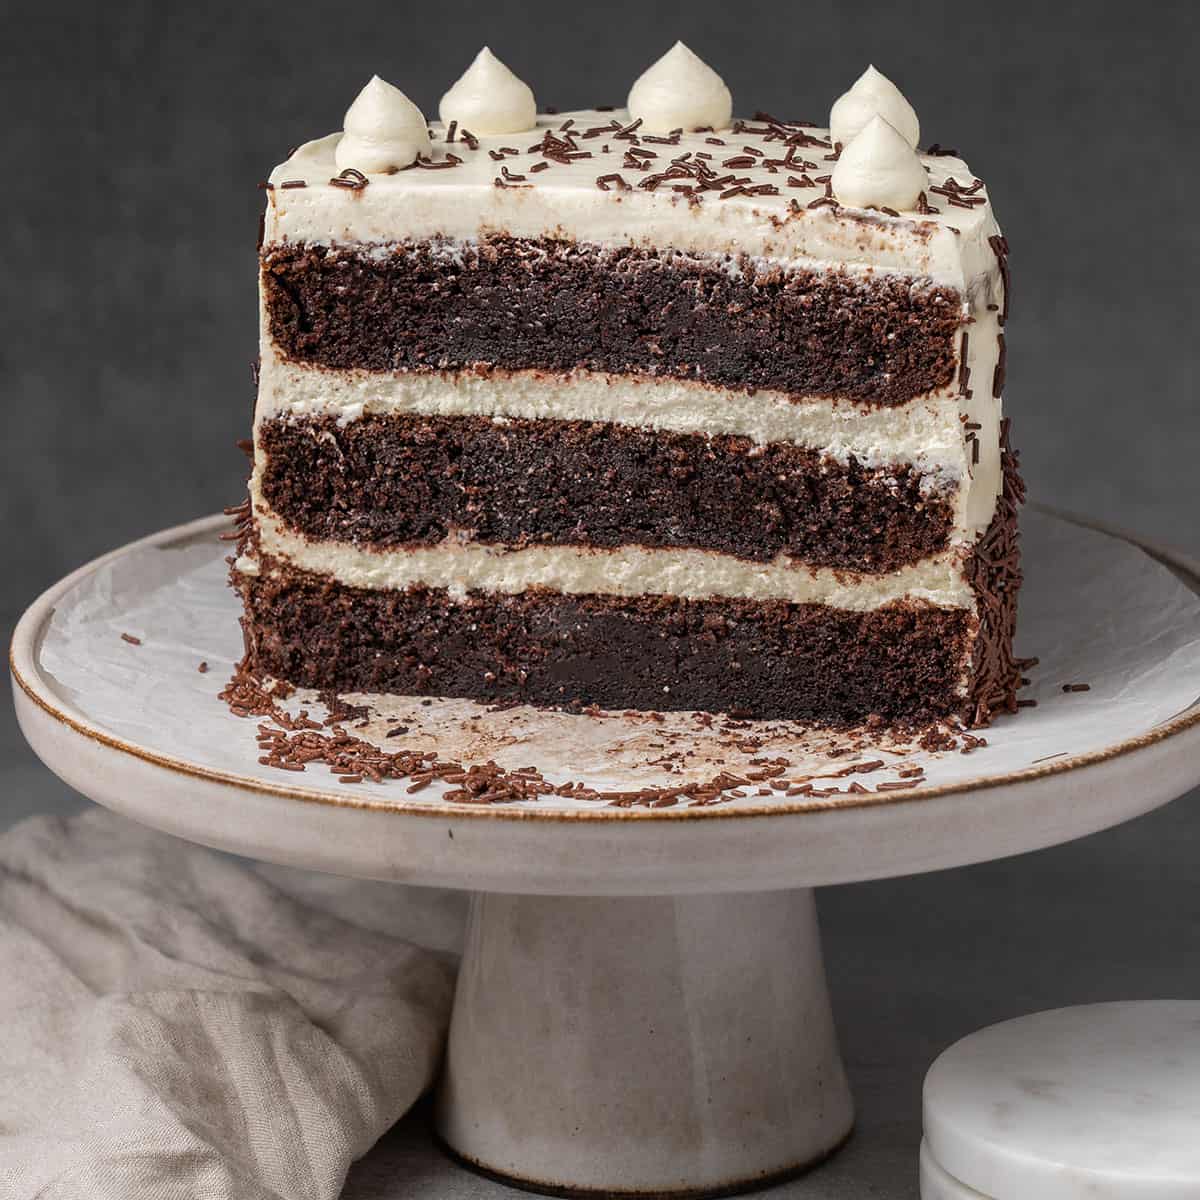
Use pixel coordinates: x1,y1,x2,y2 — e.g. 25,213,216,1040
233,47,1020,722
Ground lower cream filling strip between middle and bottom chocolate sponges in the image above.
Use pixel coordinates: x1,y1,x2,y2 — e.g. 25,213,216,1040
246,494,974,611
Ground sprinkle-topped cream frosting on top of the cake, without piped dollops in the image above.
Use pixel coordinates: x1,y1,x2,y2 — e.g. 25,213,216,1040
265,109,998,292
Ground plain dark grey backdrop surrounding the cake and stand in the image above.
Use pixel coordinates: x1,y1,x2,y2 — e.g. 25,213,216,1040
0,0,1200,1196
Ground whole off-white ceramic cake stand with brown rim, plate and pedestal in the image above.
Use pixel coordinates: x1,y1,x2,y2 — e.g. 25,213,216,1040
11,511,1200,1195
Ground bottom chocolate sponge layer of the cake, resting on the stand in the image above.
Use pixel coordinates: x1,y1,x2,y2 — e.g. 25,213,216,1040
235,559,976,722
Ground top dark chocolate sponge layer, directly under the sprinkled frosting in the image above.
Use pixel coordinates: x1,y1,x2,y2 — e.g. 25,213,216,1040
262,238,962,404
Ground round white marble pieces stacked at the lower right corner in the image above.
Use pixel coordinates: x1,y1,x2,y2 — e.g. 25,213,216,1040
920,1000,1200,1200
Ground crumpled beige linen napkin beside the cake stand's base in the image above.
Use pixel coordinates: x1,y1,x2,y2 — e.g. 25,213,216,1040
0,810,458,1200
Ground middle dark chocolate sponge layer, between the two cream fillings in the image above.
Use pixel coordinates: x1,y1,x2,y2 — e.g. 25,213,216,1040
258,414,954,572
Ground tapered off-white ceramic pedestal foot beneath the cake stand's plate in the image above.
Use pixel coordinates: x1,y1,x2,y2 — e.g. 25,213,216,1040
437,889,853,1195
